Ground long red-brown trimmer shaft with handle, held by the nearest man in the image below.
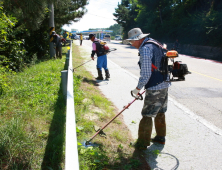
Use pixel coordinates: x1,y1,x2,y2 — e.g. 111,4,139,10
85,90,145,145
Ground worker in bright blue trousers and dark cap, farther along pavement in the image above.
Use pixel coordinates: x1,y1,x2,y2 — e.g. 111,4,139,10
89,34,110,80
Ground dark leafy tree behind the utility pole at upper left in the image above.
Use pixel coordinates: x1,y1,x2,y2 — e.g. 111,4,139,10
1,0,88,70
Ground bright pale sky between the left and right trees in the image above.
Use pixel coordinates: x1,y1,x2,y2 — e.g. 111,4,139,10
63,0,121,31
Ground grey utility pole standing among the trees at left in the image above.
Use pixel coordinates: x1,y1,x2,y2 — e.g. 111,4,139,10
49,3,55,58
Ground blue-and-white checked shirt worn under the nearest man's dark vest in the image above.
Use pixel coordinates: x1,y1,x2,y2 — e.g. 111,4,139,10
137,37,171,90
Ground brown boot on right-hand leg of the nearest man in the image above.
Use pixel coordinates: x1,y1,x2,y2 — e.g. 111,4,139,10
152,113,166,145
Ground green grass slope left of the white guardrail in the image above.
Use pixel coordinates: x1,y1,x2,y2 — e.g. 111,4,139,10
0,48,67,170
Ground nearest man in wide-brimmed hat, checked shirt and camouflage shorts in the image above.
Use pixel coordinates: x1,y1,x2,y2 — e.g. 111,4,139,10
128,28,171,150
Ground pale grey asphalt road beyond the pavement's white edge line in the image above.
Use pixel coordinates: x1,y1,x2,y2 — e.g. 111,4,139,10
83,40,222,129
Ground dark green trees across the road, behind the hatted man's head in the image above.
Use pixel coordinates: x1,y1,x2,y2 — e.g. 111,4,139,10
114,0,222,47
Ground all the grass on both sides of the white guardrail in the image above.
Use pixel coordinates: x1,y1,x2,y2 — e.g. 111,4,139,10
0,41,150,170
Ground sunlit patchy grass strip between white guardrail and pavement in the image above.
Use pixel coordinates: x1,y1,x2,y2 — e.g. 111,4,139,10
73,42,149,170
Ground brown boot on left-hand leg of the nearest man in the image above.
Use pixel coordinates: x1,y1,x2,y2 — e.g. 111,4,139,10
137,116,153,150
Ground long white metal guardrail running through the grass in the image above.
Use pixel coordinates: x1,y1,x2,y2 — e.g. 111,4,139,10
62,41,79,170
